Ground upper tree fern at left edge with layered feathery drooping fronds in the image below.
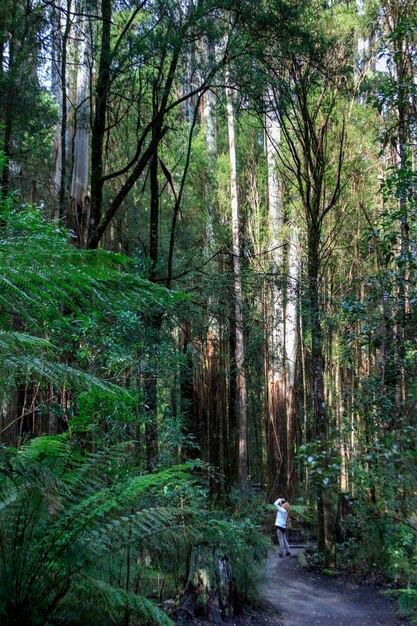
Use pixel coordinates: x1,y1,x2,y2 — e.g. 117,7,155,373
0,203,180,414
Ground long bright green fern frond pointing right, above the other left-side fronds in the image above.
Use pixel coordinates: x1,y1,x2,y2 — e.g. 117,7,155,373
0,237,178,322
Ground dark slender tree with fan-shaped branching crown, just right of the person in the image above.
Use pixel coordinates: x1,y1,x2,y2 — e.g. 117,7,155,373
268,39,352,565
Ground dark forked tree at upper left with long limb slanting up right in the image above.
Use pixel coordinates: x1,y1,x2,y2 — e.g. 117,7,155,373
88,0,229,248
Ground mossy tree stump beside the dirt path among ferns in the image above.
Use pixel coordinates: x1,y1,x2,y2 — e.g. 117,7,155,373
176,545,237,626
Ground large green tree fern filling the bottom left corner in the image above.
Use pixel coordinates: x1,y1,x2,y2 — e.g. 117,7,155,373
0,438,196,626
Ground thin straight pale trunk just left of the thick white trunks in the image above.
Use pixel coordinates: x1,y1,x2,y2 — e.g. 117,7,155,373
226,71,248,492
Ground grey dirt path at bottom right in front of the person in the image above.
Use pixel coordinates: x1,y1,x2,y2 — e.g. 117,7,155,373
261,550,408,626
